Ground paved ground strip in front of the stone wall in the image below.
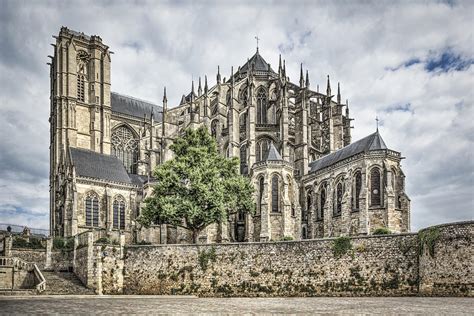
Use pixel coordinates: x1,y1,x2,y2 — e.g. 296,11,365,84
0,296,474,315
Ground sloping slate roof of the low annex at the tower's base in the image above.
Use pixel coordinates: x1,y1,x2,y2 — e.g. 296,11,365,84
70,148,132,184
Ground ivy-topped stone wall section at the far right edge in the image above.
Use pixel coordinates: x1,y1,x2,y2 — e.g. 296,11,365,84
419,222,474,296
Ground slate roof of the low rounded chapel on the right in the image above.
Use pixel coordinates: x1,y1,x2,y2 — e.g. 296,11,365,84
309,130,388,172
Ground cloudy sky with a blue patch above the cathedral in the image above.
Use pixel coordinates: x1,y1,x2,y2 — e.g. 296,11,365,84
0,0,474,231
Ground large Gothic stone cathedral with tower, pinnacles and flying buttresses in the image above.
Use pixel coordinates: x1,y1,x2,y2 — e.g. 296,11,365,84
49,27,410,243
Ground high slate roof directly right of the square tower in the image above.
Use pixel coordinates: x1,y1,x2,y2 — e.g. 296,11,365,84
110,92,163,122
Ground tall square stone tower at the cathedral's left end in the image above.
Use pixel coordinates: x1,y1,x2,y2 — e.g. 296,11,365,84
49,27,111,234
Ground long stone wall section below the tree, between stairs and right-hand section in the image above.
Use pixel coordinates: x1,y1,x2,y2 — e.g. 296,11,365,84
123,234,418,296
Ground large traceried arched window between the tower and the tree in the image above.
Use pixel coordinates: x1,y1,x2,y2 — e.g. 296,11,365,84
112,125,138,173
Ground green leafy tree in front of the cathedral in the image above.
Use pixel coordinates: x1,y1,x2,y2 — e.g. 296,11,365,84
139,127,255,243
